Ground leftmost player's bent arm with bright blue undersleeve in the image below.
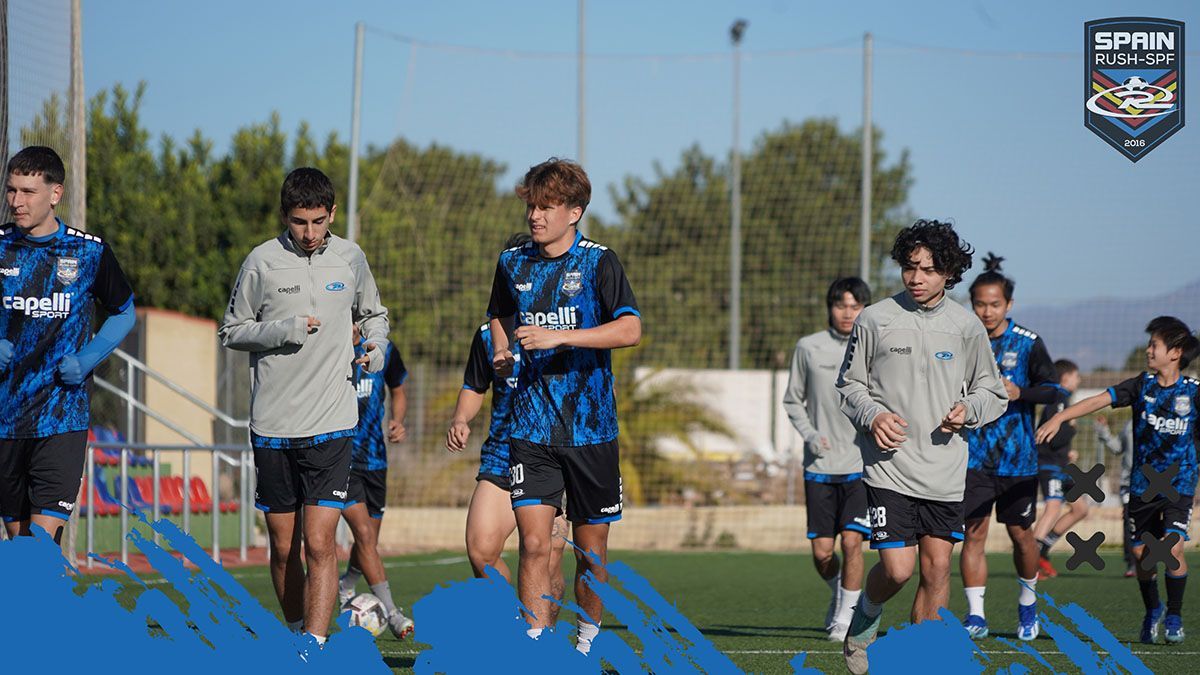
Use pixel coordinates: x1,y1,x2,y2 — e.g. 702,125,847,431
59,243,137,384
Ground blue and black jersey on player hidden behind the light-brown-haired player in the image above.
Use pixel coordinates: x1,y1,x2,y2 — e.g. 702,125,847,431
462,323,521,478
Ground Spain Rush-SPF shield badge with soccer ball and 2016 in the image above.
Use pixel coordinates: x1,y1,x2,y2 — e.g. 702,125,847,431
1084,17,1184,162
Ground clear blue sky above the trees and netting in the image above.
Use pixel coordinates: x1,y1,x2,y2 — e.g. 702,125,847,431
75,0,1200,304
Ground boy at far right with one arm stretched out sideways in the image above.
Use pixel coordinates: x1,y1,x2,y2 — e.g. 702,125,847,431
1038,316,1200,644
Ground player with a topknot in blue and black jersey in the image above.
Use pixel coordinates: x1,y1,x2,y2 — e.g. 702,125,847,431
959,253,1056,640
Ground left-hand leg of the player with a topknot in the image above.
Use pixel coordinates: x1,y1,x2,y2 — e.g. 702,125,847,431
959,470,998,640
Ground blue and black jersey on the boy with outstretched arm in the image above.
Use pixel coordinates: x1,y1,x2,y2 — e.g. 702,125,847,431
1109,372,1200,496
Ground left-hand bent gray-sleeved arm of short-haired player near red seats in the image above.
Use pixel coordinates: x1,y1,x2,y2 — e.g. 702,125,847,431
217,265,320,352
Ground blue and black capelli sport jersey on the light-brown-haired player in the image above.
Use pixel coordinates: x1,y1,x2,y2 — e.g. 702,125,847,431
487,234,641,447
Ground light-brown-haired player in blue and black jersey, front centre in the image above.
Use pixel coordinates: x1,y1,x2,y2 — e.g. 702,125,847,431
487,159,642,653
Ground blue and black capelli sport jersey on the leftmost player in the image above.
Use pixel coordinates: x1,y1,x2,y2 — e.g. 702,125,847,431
0,221,133,438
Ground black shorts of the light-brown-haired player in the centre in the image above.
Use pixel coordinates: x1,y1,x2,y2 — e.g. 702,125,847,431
509,438,622,524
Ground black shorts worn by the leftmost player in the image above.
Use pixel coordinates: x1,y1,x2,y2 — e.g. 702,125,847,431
0,431,88,522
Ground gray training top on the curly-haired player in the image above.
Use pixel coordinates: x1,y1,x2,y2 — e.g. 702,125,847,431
838,292,1008,502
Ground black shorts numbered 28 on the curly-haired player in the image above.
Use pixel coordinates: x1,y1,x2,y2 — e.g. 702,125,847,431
866,485,966,549
